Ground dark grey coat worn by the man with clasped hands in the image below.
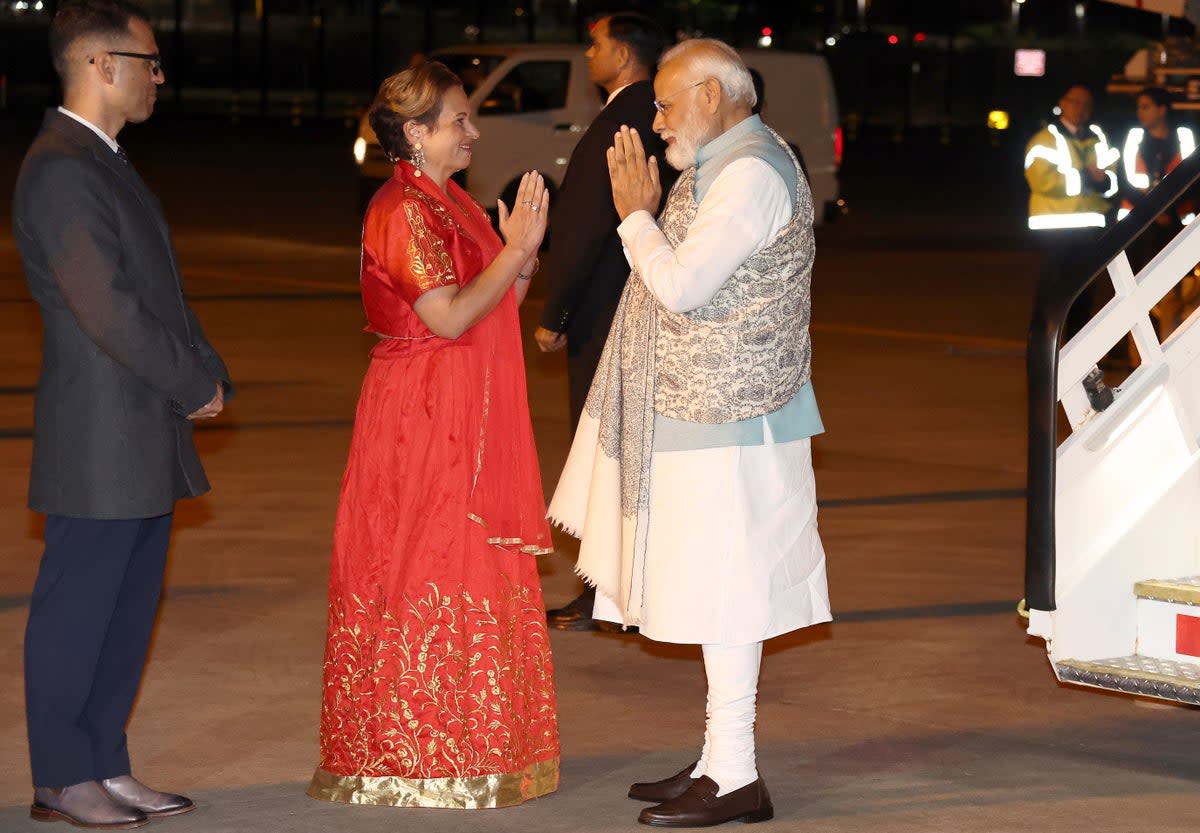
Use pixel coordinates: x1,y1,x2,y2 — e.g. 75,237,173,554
13,110,233,519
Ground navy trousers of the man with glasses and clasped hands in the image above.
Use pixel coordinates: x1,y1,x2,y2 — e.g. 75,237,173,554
25,515,172,787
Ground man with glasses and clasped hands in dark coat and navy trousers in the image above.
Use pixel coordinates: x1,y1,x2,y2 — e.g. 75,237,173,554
13,0,233,827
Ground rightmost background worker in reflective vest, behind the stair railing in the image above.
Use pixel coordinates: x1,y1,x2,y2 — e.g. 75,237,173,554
1117,86,1200,337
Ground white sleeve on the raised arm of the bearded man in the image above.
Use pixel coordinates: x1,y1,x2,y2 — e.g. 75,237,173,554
617,157,792,312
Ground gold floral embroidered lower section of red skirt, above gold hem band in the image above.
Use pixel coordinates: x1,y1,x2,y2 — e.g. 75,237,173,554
320,582,558,780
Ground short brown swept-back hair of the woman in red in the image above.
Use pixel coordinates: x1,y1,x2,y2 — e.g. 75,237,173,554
367,61,462,161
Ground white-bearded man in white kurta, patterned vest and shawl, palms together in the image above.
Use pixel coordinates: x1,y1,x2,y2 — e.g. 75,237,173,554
550,40,830,827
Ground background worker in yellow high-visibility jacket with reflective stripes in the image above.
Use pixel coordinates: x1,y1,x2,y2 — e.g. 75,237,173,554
1025,84,1121,338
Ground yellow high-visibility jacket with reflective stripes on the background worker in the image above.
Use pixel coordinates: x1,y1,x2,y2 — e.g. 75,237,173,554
1025,124,1121,230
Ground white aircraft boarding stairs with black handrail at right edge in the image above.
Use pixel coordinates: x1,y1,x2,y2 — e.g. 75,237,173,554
1026,147,1200,705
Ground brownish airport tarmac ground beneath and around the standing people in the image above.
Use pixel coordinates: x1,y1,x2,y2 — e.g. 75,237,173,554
0,121,1200,833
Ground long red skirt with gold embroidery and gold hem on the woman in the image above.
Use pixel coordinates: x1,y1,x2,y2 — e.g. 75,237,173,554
308,328,559,808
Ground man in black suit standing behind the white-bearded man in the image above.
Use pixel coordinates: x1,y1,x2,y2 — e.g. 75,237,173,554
534,13,679,630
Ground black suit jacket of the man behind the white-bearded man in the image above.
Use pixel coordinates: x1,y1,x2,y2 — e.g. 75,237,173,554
541,80,679,423
